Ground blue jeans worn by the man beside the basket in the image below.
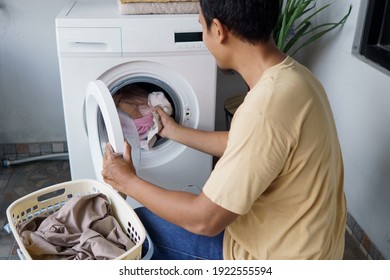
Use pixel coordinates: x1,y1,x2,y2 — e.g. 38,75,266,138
135,207,223,260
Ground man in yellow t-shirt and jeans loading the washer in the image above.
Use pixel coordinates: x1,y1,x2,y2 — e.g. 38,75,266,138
102,0,346,259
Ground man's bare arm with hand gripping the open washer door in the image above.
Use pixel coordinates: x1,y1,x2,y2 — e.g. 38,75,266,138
102,143,238,236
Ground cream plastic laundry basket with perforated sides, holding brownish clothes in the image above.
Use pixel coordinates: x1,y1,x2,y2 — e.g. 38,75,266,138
7,180,151,260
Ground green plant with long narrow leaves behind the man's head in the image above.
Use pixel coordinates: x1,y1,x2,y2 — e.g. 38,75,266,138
273,0,352,55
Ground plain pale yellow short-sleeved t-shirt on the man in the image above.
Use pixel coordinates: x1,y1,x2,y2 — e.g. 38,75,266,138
203,57,346,260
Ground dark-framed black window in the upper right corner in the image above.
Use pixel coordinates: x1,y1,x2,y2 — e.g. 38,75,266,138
354,0,390,73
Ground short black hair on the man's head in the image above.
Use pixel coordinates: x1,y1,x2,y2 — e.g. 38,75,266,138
200,0,280,44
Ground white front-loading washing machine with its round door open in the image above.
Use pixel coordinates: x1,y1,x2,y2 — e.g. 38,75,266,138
56,0,217,206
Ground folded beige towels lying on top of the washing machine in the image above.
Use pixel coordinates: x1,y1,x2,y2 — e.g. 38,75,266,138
118,0,199,15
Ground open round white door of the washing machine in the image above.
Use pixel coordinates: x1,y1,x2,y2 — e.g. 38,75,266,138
85,80,141,180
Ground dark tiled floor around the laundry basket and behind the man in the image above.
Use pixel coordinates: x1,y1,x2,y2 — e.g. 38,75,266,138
0,160,367,260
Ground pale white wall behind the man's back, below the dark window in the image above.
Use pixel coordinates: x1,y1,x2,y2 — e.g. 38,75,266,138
297,0,390,259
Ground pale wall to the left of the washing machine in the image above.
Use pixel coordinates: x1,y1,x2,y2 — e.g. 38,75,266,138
0,0,69,143
